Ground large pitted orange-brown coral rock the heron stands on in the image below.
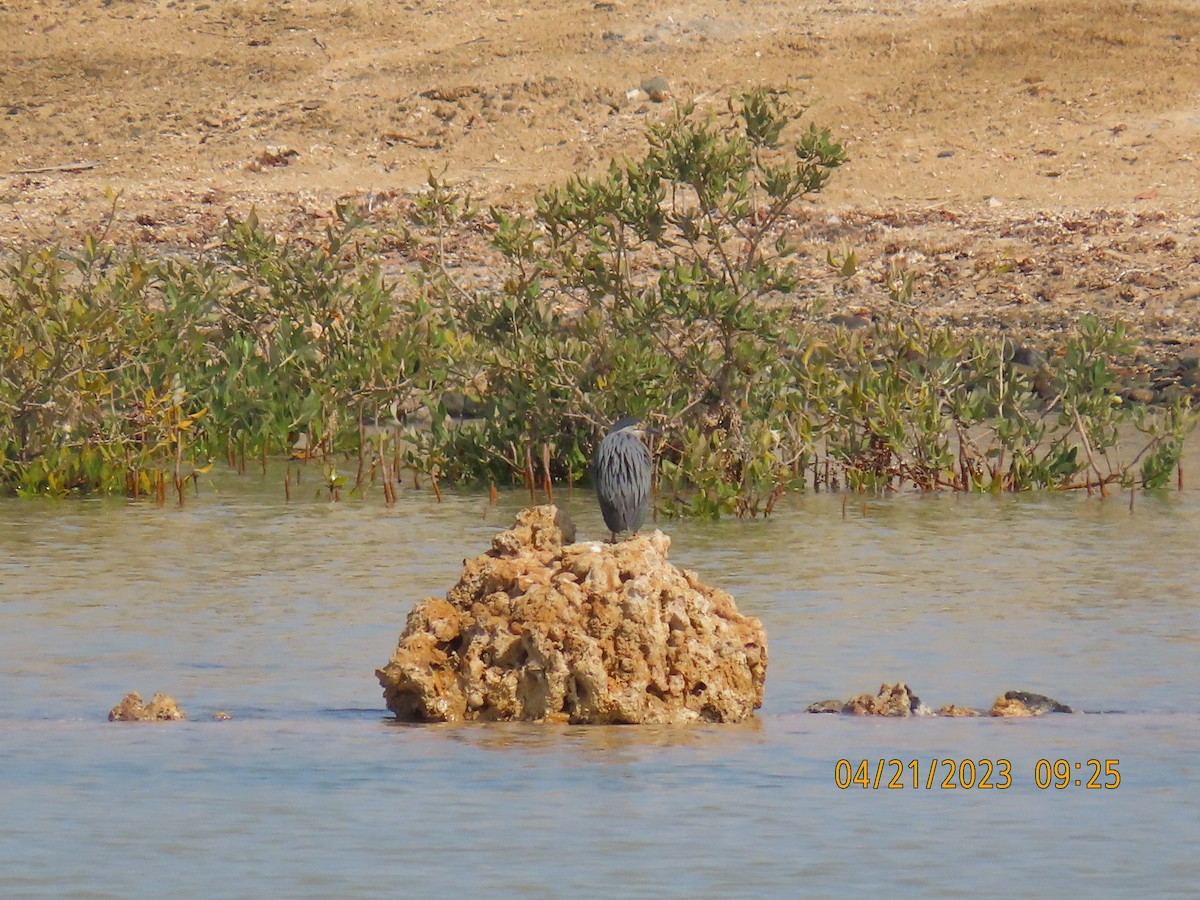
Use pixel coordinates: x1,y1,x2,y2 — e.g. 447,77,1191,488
376,506,767,724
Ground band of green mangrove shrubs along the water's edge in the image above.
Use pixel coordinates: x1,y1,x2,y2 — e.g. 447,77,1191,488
0,89,1194,508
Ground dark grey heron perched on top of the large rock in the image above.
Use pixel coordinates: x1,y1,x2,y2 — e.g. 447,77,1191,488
592,415,654,542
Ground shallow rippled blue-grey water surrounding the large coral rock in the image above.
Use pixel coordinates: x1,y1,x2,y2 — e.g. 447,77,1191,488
0,475,1200,898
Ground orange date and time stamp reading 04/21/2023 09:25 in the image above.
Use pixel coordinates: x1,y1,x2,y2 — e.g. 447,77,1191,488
833,758,1121,791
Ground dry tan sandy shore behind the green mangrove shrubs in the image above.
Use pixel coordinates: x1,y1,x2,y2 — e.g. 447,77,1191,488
0,0,1200,356
